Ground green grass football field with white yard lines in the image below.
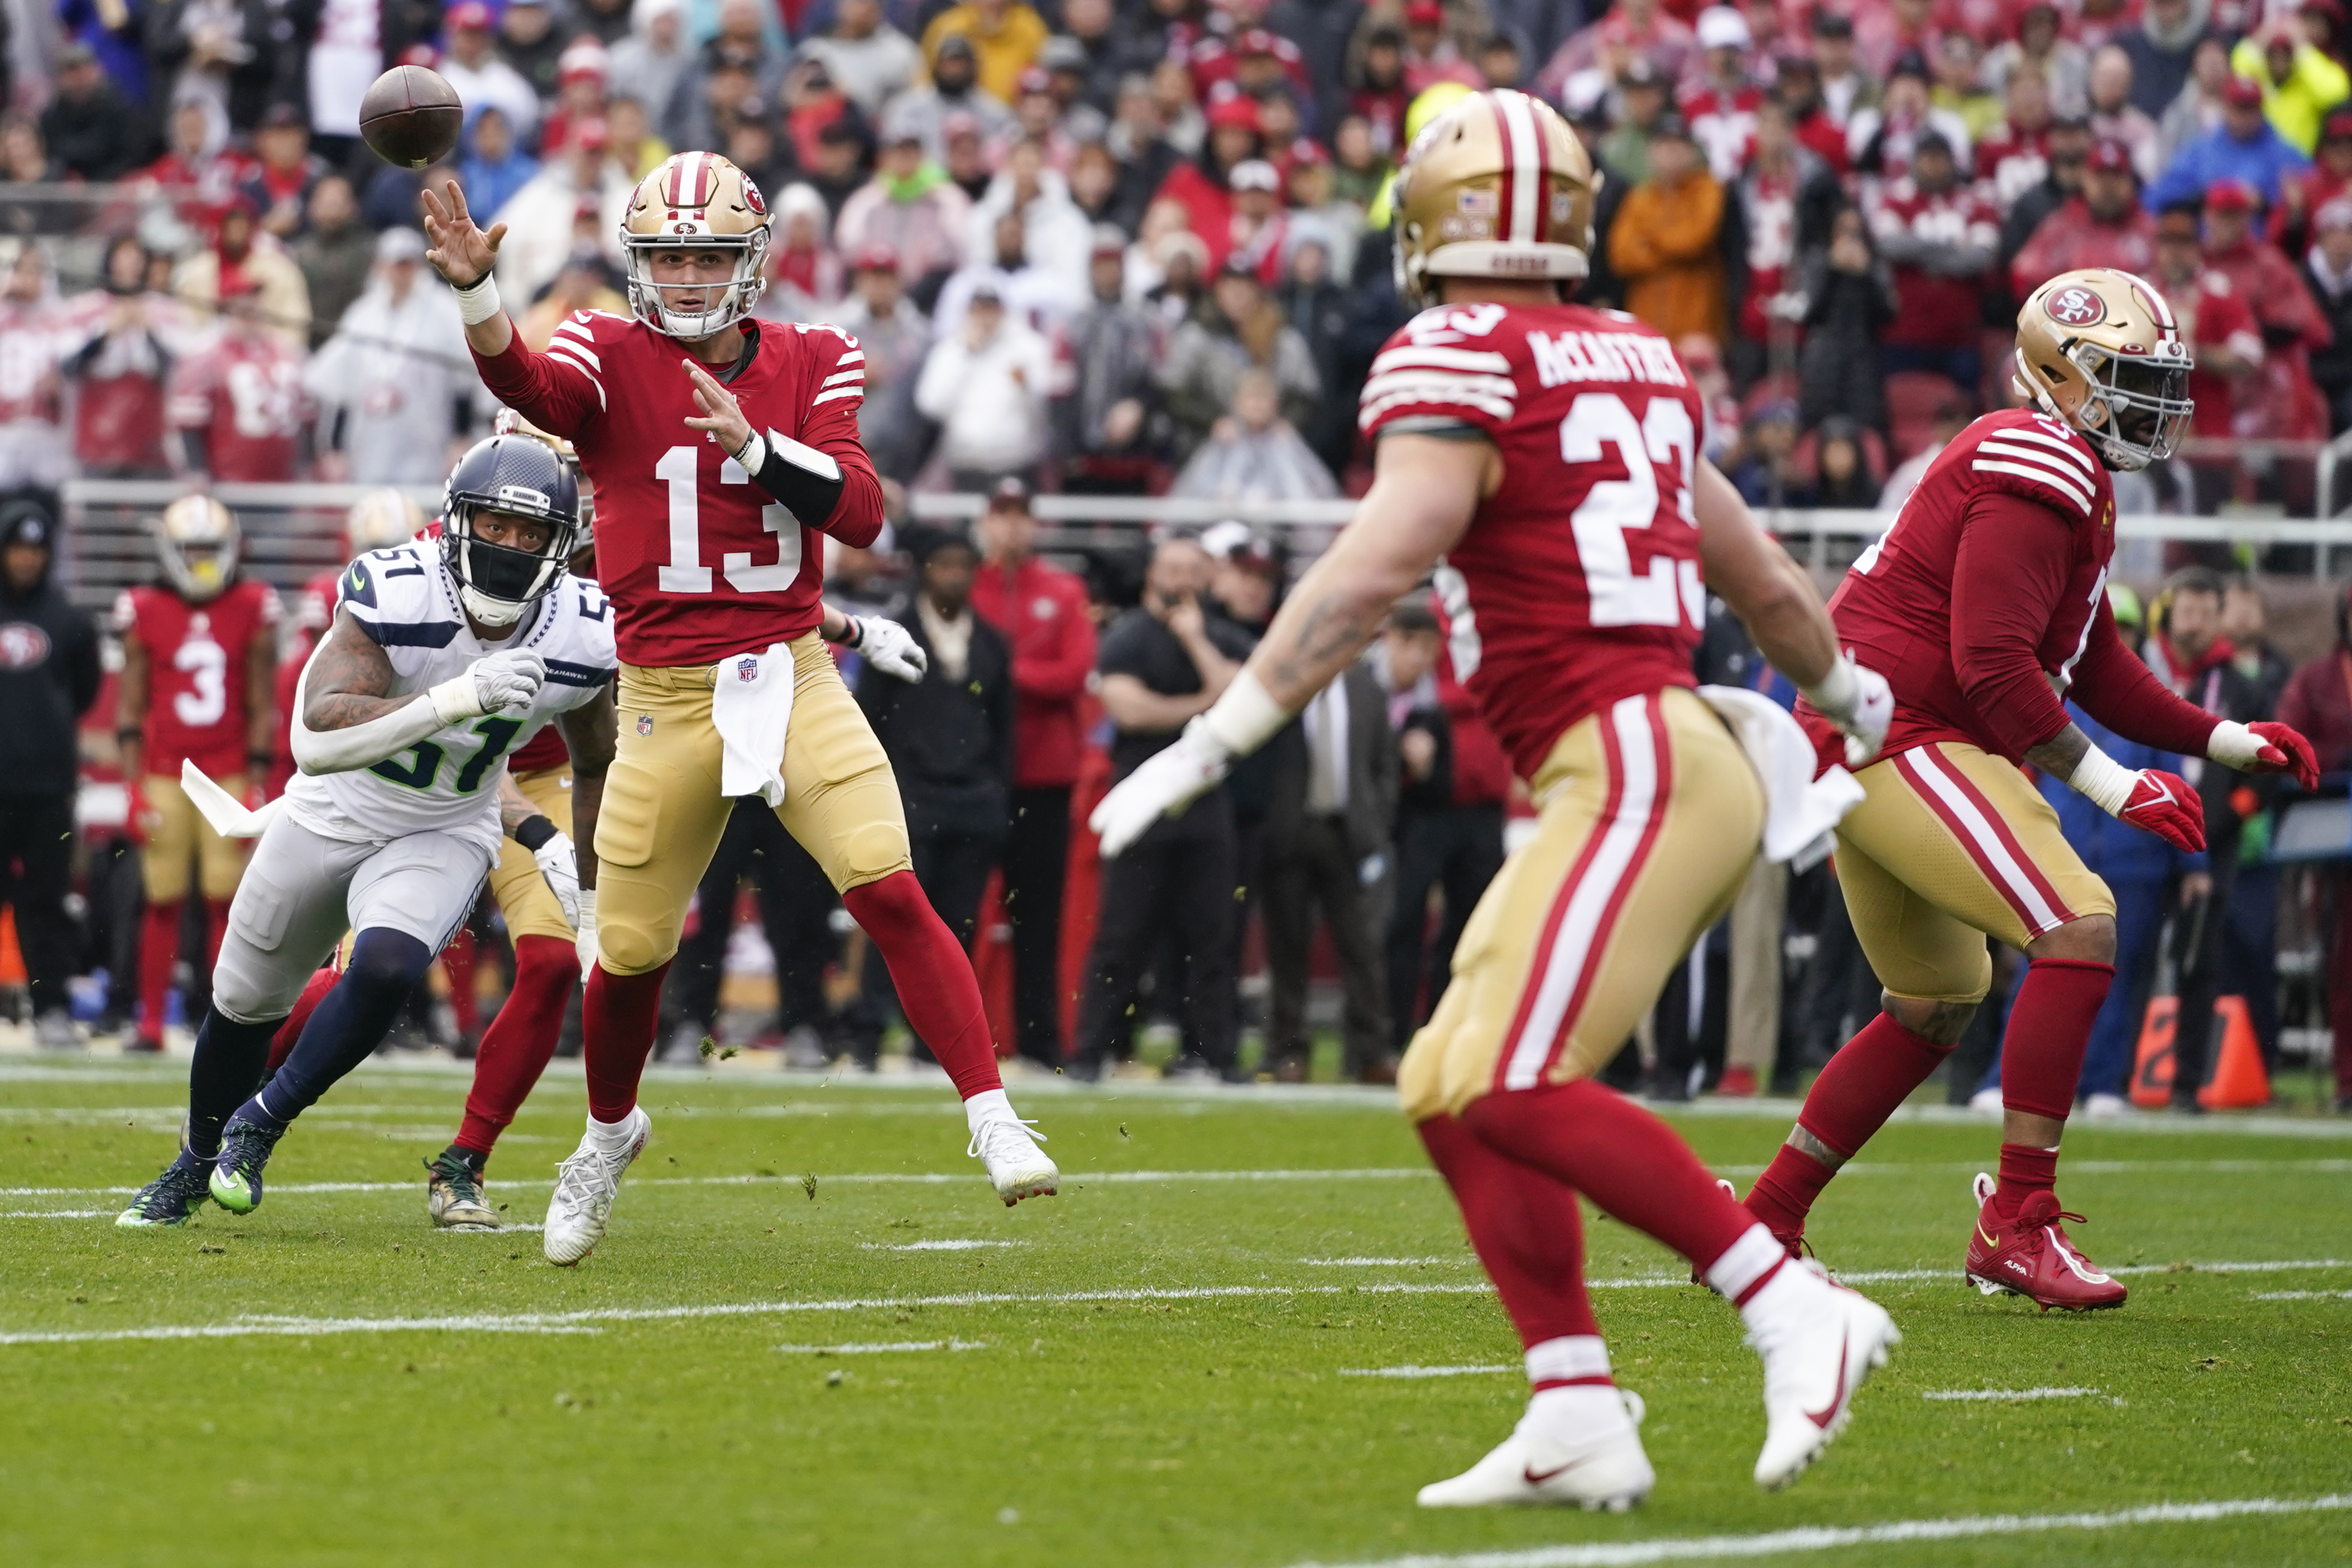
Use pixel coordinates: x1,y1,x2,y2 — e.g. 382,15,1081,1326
0,1056,2352,1568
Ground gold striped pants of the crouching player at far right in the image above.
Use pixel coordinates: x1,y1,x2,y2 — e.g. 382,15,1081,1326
1837,740,2114,1002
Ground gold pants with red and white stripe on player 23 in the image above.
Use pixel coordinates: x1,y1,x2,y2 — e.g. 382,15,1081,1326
1397,686,1764,1122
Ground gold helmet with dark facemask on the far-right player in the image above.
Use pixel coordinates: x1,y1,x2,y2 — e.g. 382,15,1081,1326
2013,268,2197,473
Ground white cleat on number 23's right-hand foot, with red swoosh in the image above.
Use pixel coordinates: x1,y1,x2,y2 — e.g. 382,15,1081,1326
1748,1267,1903,1488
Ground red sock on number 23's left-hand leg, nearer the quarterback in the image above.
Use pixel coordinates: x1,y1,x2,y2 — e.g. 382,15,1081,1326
1414,1117,1609,1354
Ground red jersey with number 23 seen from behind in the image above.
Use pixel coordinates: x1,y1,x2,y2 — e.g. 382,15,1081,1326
1364,306,1707,778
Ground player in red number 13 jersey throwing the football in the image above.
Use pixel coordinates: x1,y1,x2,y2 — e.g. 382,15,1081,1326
426,153,1058,1265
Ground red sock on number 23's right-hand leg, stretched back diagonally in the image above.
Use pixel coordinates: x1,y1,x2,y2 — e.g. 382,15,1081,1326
1463,1079,1755,1272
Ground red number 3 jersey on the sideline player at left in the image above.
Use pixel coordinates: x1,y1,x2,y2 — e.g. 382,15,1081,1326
115,578,280,778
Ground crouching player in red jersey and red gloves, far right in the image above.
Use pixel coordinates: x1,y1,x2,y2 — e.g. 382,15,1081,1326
1748,268,2319,1310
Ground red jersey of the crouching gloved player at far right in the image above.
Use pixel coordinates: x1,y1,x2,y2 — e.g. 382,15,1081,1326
1799,409,2114,762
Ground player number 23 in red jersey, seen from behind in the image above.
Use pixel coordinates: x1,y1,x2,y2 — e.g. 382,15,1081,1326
1094,89,1900,1507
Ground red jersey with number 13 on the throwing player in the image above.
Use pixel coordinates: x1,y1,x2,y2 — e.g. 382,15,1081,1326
475,310,882,667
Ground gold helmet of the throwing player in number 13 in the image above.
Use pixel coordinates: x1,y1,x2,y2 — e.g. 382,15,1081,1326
621,153,767,339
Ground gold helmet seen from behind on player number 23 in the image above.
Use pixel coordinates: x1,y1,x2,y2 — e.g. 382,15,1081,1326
1397,87,1602,306
